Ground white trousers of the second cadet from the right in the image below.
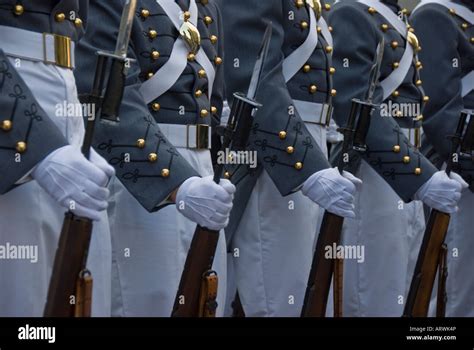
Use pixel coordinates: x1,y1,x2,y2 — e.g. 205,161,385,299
343,161,425,317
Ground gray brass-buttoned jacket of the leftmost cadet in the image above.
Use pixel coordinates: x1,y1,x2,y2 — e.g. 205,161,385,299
0,0,88,194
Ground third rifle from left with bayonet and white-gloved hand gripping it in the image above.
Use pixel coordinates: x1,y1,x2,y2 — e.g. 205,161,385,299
301,39,384,317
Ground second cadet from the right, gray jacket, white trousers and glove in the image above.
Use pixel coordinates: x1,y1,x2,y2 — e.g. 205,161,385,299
329,0,463,316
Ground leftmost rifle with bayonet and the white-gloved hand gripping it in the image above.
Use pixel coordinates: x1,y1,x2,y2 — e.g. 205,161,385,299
43,0,137,317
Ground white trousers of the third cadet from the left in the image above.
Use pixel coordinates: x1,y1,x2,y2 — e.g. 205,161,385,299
228,124,327,317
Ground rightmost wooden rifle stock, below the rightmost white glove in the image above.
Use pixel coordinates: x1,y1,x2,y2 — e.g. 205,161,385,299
403,209,450,317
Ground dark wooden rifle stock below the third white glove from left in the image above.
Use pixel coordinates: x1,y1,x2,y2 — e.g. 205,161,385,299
301,211,344,317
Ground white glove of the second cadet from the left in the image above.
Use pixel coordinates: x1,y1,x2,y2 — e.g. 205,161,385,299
176,176,235,231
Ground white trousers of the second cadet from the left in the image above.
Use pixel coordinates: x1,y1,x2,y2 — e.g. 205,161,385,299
109,148,227,317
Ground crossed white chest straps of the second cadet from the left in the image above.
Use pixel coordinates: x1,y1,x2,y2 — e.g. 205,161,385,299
140,0,216,103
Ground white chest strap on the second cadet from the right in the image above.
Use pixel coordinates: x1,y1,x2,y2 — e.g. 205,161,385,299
358,0,414,100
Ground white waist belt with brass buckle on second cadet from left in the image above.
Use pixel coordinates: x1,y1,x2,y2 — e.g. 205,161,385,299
158,124,212,149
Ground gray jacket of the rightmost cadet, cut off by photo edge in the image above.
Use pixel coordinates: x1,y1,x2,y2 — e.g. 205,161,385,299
412,0,474,191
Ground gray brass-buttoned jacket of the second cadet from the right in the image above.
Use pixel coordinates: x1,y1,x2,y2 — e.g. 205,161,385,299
329,1,436,202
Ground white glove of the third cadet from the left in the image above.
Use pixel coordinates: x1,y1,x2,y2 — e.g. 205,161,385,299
301,168,362,218
